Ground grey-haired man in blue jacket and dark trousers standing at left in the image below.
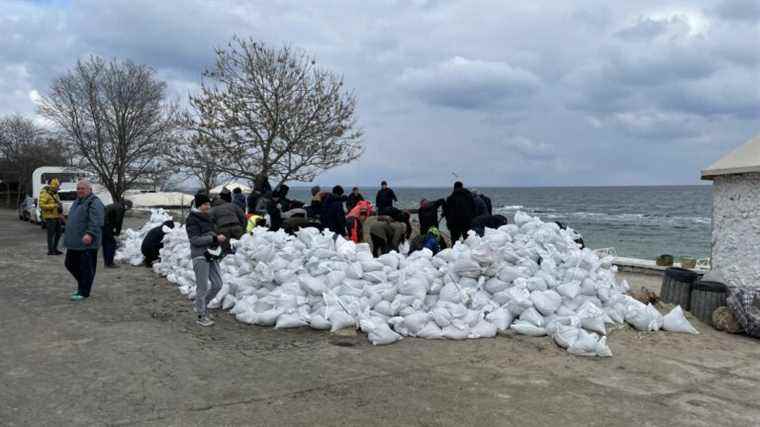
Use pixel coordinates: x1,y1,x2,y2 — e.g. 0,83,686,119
63,179,105,301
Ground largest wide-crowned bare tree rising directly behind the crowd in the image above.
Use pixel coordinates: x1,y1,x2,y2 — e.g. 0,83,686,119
190,37,362,188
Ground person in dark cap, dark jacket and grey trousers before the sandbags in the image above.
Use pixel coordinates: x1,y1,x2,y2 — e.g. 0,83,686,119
185,194,227,326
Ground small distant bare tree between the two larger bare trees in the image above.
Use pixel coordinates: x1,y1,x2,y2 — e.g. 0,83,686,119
164,132,222,193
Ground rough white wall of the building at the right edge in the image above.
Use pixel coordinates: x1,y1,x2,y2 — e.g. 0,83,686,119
712,173,760,287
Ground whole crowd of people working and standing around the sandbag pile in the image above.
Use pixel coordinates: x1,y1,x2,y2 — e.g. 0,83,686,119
39,176,507,326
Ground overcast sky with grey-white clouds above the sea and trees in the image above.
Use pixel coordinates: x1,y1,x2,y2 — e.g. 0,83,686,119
0,0,760,186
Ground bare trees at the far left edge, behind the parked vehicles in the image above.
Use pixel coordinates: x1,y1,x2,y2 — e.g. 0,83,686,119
0,115,68,206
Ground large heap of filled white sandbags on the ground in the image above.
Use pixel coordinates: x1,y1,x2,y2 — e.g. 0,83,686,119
117,212,690,356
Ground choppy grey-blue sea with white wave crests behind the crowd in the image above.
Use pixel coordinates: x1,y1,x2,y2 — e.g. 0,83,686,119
289,185,712,259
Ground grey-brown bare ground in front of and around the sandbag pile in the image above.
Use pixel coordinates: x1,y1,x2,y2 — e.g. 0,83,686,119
0,210,760,426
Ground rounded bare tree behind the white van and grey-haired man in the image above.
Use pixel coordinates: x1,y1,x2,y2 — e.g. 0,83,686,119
40,56,177,201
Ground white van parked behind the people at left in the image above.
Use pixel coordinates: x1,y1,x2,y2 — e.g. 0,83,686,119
29,166,111,224
